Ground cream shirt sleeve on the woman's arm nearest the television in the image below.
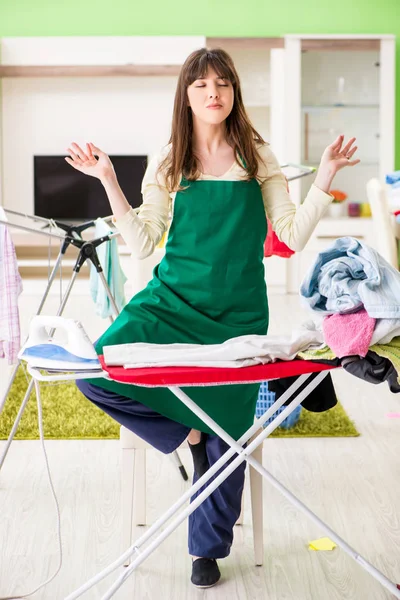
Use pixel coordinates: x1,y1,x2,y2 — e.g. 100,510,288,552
114,149,171,259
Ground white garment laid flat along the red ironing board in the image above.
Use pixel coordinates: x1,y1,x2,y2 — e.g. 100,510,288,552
103,321,325,369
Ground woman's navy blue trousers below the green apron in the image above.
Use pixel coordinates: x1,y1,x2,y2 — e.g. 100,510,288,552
76,379,246,558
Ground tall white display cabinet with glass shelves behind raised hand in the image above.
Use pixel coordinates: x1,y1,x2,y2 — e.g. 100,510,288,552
284,35,395,293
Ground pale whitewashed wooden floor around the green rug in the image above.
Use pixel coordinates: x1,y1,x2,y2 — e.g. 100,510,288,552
0,288,400,600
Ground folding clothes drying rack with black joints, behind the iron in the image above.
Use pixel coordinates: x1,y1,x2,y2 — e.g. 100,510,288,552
0,208,188,481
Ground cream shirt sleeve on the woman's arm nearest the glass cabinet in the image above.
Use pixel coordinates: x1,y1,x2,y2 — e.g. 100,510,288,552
258,144,333,252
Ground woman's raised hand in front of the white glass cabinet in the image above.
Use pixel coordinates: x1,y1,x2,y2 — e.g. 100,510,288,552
314,135,360,192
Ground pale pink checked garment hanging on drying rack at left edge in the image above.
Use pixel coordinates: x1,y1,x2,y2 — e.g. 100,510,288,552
0,223,22,365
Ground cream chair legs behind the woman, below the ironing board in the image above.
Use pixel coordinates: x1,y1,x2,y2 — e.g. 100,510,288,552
120,426,264,566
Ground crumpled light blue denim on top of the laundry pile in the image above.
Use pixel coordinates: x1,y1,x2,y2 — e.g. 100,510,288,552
300,237,400,319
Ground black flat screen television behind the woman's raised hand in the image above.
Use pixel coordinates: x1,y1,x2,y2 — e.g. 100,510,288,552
33,155,147,222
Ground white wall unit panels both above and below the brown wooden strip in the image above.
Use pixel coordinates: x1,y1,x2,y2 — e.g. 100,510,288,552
0,36,205,213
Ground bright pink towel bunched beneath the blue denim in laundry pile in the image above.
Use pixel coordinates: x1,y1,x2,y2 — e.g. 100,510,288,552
322,309,376,358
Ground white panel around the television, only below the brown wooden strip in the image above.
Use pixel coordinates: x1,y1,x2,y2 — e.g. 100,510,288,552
1,77,177,214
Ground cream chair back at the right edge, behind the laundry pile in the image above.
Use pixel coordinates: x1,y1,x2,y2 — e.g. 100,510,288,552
367,178,399,269
